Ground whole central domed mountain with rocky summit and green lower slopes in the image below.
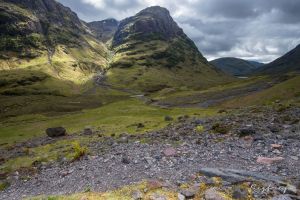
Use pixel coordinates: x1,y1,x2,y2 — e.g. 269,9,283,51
107,6,229,92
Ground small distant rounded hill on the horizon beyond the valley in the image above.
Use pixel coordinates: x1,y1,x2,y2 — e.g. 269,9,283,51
210,57,263,76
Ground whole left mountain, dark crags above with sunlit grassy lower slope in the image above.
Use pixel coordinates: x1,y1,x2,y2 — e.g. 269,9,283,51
0,0,107,83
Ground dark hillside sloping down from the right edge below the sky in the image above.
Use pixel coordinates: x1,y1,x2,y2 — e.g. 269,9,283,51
256,44,300,75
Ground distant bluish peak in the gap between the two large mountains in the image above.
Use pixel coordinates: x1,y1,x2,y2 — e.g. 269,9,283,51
87,19,119,42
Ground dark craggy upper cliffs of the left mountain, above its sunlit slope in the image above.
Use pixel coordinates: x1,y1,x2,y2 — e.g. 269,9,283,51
0,0,88,57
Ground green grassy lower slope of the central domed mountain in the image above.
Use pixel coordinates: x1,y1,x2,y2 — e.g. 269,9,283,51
107,39,229,92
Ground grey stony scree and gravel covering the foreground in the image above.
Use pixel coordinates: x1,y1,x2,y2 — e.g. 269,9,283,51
0,106,300,200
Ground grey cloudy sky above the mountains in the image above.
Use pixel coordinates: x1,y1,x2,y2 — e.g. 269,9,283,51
58,0,300,62
